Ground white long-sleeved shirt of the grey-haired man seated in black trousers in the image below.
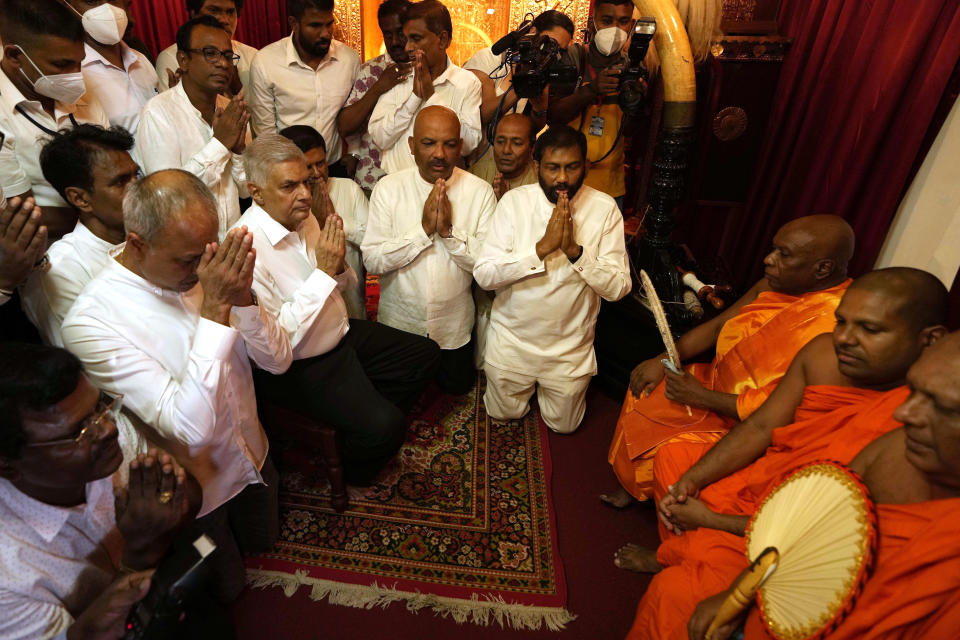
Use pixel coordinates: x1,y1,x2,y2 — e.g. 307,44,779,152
236,204,357,360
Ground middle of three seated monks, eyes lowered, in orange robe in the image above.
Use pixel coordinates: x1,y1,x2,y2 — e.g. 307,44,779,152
620,269,948,638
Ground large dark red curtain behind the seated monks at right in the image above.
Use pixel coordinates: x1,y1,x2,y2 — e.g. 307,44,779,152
720,0,960,285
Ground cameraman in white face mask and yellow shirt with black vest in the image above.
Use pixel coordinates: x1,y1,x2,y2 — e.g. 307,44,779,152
547,0,645,211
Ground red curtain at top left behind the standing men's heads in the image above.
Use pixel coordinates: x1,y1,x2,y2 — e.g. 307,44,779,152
130,0,289,55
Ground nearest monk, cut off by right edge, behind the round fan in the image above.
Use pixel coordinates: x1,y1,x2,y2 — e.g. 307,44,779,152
688,333,960,640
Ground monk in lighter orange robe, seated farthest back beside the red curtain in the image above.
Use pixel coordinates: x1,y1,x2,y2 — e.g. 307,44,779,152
601,215,854,507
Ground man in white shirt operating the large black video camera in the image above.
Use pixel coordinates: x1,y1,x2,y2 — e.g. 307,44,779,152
463,9,574,132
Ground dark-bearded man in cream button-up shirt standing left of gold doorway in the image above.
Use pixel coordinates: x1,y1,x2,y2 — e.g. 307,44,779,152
250,0,360,178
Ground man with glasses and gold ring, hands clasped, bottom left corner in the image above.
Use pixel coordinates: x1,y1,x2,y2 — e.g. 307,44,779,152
0,343,199,640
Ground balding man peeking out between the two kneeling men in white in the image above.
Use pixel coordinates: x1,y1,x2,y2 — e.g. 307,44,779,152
470,113,537,200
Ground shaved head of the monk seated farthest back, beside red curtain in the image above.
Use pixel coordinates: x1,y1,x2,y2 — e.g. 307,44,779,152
763,215,854,295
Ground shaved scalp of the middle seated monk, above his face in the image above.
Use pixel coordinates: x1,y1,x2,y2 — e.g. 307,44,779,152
850,267,950,330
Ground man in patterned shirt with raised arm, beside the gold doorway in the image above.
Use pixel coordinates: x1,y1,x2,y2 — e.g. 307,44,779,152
337,0,410,192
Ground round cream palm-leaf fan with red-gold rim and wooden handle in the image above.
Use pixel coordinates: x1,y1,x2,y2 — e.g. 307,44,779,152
707,461,876,640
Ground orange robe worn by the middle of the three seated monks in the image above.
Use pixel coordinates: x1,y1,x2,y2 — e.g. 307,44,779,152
628,387,909,640
